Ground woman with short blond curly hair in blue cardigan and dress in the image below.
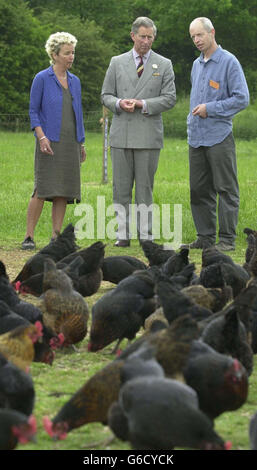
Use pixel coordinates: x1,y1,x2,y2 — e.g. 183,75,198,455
22,32,86,250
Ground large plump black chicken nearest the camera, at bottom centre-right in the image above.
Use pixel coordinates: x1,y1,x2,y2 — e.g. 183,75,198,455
108,376,230,450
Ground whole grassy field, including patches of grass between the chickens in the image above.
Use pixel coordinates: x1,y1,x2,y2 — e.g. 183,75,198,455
0,132,257,450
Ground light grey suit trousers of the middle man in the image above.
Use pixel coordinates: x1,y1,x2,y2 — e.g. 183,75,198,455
111,147,160,240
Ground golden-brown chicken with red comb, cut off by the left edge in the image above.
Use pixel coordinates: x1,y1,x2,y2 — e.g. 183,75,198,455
0,322,43,372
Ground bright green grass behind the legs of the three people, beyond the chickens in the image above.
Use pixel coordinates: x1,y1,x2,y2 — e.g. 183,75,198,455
0,132,257,254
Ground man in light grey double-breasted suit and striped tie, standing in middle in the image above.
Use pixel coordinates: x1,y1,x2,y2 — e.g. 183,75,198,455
101,17,176,247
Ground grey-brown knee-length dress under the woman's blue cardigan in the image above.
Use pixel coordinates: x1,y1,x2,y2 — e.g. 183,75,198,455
32,87,81,204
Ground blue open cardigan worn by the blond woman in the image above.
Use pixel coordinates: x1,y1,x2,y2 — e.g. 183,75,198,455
29,66,85,143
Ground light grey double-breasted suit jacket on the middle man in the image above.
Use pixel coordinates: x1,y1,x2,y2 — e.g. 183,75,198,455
101,50,176,149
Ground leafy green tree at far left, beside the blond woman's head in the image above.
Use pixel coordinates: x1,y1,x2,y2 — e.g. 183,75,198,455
0,0,44,113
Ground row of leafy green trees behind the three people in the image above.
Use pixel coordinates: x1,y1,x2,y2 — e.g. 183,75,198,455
0,0,257,114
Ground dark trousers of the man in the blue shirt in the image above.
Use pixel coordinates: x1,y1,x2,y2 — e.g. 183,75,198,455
189,133,239,244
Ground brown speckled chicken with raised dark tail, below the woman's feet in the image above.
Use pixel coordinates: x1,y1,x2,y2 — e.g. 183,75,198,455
39,258,89,346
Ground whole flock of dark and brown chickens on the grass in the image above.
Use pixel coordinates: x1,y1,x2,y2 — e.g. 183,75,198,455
0,224,257,450
